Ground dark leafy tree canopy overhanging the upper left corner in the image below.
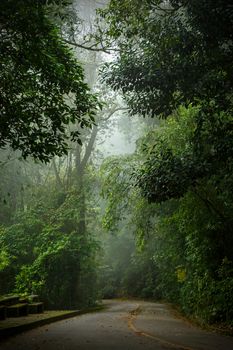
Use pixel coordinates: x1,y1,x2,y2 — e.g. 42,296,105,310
0,0,98,161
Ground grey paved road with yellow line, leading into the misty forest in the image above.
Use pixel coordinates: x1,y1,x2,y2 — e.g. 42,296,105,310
0,300,233,350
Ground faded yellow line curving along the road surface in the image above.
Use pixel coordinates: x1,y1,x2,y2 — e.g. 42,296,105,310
128,304,195,350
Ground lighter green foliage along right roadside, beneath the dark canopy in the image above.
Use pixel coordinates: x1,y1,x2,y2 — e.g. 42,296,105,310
100,107,233,323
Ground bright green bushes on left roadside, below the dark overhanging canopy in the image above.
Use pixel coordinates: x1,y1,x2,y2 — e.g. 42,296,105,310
0,157,99,309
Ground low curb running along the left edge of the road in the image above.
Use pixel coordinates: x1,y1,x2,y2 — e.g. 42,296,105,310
0,305,105,342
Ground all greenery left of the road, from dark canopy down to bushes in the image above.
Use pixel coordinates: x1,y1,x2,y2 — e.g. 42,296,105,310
0,0,104,309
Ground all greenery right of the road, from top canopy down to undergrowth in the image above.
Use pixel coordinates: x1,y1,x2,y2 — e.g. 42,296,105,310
97,0,233,323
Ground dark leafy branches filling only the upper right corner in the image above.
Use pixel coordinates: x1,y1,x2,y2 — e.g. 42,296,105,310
101,0,233,116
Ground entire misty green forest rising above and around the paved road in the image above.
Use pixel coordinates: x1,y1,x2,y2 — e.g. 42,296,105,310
0,0,233,325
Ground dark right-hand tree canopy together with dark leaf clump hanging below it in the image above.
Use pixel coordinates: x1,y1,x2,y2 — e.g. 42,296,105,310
98,0,233,202
